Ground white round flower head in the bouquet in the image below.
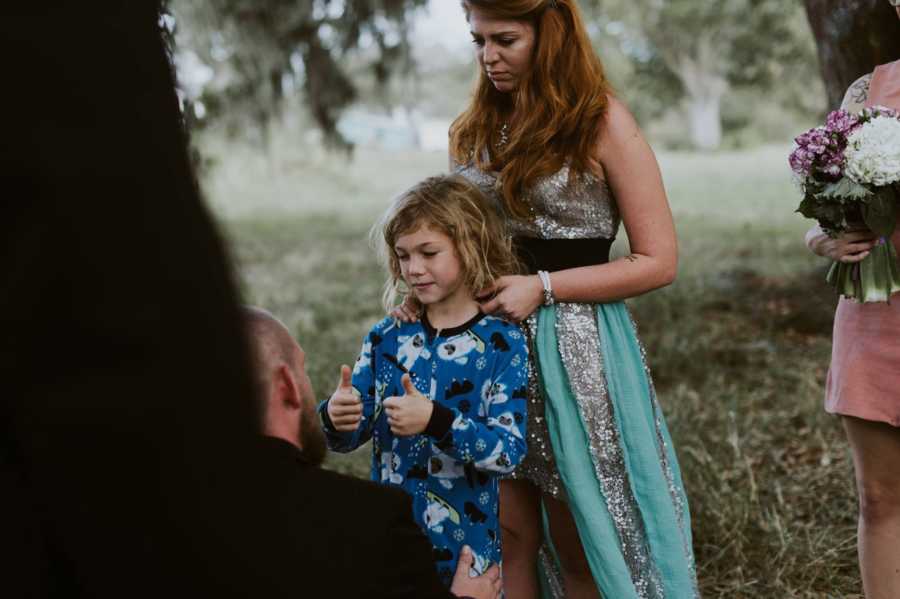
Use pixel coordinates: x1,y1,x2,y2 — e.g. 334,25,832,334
844,116,900,187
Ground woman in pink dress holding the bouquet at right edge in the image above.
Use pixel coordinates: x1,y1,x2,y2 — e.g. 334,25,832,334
806,0,900,599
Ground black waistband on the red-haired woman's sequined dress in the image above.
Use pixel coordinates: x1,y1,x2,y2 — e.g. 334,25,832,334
515,237,615,274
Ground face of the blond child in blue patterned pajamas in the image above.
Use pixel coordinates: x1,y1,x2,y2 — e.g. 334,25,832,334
394,225,472,307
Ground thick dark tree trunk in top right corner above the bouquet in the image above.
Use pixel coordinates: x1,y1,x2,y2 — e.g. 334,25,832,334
803,0,900,108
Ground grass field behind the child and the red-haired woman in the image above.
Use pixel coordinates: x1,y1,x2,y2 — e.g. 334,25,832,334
205,138,861,598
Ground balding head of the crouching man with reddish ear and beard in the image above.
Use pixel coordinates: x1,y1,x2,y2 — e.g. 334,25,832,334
244,306,325,465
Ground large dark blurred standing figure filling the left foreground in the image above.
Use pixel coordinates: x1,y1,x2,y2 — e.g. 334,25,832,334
0,0,303,598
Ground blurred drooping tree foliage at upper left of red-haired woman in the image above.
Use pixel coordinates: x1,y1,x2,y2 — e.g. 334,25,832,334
168,0,427,148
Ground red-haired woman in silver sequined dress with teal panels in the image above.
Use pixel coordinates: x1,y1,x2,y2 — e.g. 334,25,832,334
450,0,698,599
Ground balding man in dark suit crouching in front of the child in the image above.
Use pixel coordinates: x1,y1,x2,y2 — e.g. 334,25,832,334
246,308,500,599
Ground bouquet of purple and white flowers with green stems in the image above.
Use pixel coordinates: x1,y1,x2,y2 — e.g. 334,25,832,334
789,106,900,302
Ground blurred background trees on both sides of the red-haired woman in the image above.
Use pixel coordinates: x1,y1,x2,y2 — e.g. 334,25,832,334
164,0,900,155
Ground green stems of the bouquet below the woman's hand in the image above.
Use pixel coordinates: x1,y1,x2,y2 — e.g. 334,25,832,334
825,239,900,302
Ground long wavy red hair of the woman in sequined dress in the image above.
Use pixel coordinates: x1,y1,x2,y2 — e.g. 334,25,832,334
450,0,612,219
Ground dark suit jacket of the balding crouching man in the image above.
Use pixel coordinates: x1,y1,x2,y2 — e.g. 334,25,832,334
263,437,453,599
